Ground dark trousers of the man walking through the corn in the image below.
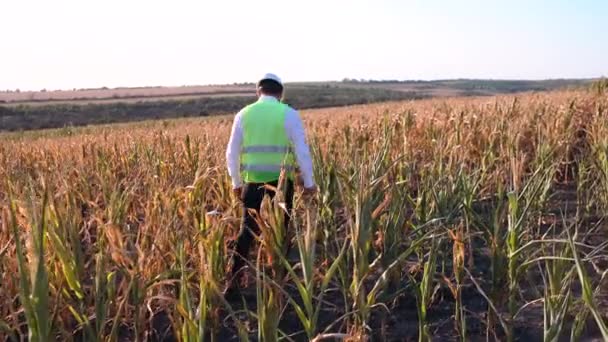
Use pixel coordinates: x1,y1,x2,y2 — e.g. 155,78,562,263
232,181,294,277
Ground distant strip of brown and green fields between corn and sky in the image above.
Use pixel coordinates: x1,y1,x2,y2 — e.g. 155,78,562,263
0,80,590,131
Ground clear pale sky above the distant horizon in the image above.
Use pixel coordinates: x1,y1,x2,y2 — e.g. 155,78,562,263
0,0,608,90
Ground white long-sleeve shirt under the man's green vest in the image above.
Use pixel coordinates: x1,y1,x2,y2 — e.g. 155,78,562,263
226,95,315,189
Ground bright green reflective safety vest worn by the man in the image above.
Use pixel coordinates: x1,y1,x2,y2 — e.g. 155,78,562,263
241,101,295,183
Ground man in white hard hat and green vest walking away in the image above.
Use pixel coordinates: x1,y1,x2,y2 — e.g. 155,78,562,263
224,74,316,296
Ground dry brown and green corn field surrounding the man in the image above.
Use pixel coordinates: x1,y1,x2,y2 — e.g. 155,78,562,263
0,89,608,341
